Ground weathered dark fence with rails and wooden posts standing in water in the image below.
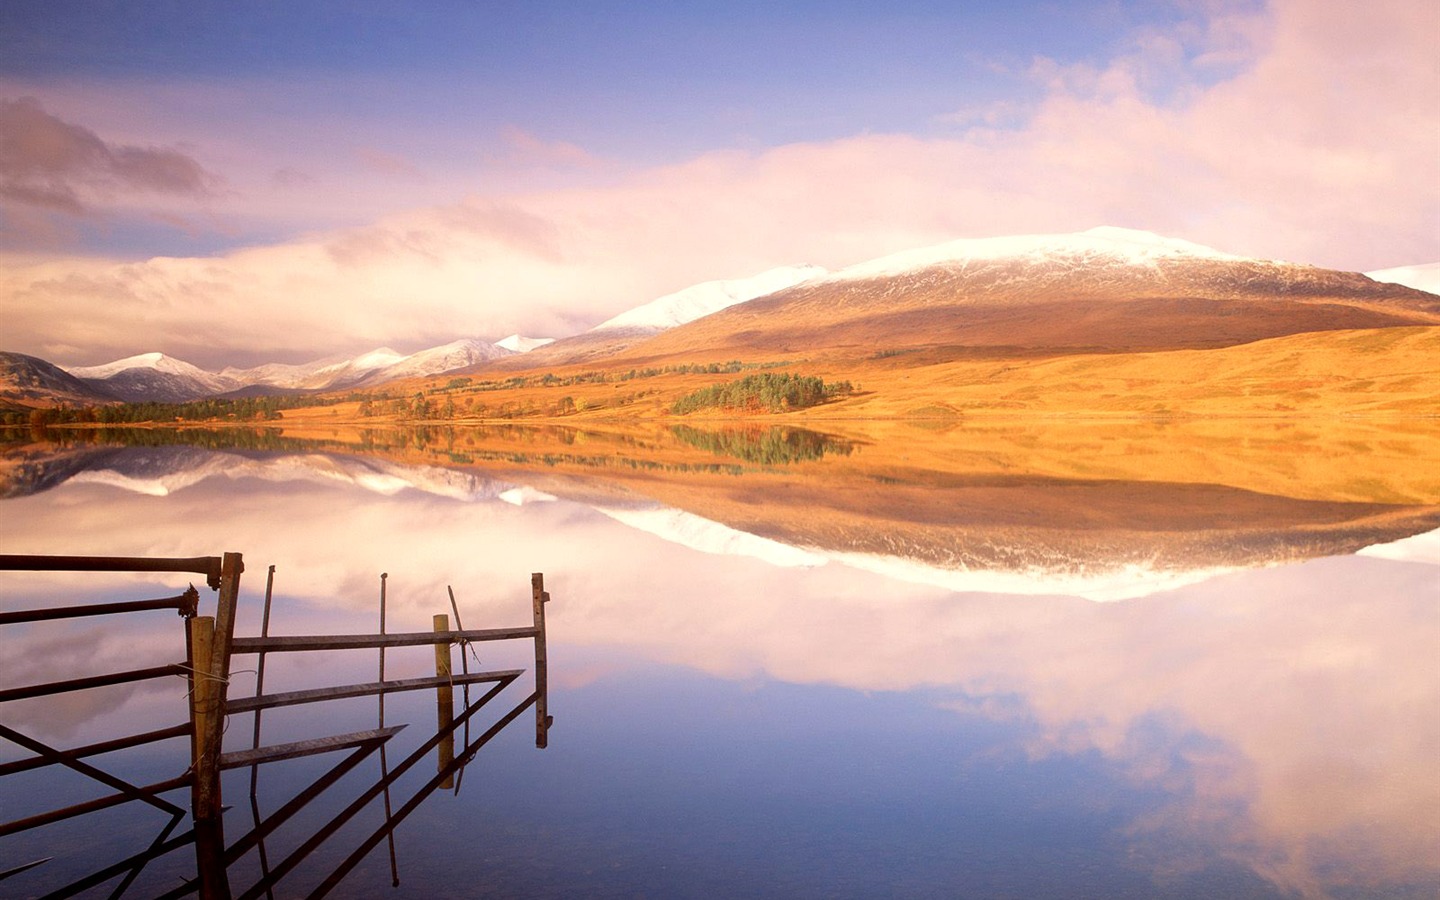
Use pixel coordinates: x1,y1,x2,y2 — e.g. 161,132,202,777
0,553,552,899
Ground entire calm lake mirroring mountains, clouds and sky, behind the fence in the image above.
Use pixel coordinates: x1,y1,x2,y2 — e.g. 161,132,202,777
0,420,1440,897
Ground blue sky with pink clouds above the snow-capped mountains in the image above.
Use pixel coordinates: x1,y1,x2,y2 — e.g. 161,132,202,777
0,0,1440,369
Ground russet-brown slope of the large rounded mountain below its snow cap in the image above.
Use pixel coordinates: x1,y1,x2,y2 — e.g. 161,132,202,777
625,259,1440,359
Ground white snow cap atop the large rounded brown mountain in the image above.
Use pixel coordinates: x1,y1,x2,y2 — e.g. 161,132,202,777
831,226,1244,281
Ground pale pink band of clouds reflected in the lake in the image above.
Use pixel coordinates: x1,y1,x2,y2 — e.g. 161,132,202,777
0,469,1440,893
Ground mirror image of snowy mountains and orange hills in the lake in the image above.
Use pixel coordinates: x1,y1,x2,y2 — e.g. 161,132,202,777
3,426,1440,599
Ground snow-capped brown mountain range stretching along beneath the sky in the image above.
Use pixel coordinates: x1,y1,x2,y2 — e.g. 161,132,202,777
0,228,1440,408
